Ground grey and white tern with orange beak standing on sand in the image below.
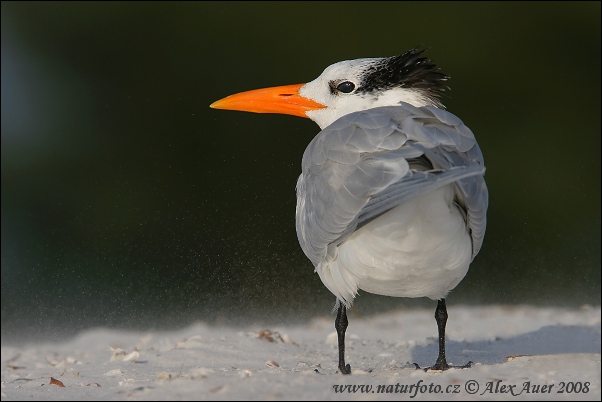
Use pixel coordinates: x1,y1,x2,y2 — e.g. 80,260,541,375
210,48,489,374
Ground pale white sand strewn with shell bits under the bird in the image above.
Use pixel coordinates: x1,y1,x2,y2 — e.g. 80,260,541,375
2,306,601,400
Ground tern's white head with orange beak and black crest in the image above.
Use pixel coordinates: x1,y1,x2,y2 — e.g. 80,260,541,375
211,49,449,128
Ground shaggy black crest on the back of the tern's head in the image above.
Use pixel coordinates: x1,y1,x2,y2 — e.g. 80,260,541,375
356,49,449,107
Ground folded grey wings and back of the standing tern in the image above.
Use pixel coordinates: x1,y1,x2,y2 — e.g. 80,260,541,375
297,103,488,266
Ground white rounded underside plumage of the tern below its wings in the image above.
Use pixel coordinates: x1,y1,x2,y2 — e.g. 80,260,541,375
316,185,472,305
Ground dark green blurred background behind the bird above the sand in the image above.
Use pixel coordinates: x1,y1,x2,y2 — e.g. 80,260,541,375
1,2,601,340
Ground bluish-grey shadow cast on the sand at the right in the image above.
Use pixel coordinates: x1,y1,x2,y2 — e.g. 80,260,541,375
411,325,600,367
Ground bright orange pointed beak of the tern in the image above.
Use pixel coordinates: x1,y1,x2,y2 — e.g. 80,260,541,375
209,84,326,117
